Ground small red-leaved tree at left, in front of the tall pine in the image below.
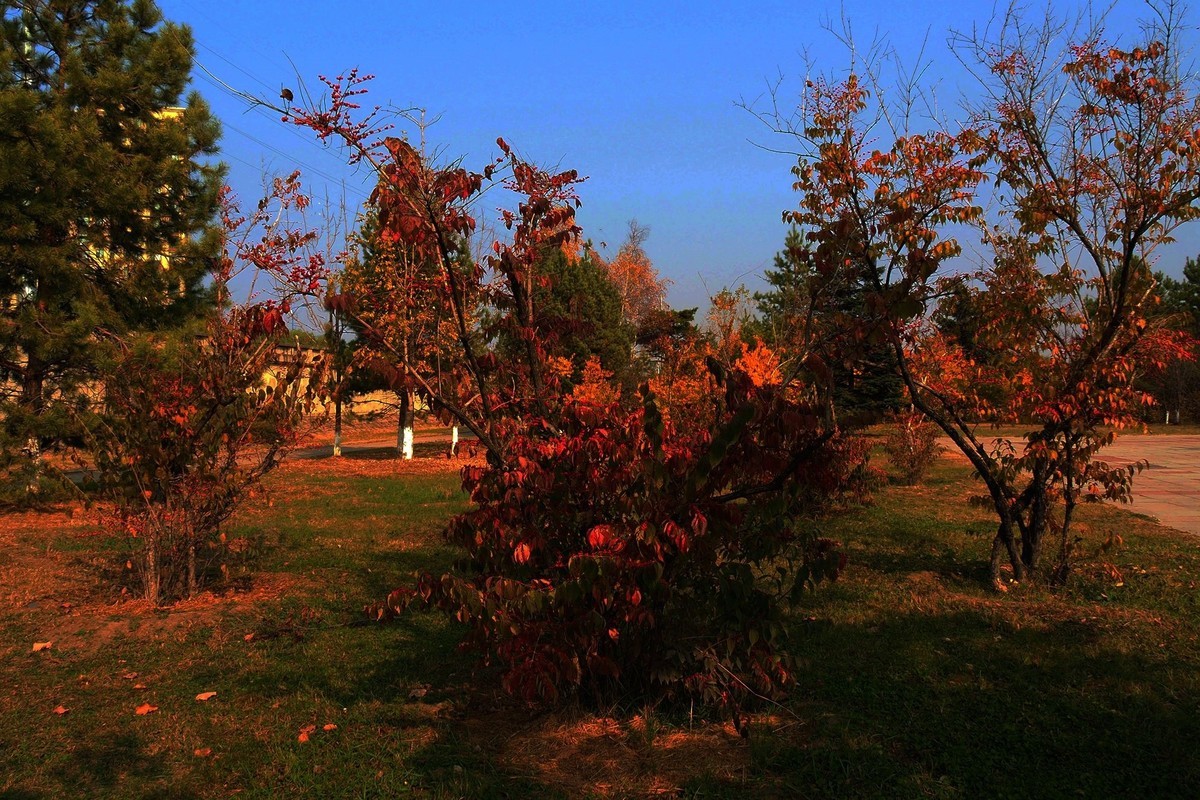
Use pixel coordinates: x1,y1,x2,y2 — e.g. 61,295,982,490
85,175,328,606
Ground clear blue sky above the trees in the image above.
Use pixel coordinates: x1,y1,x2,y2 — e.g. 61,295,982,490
158,0,1200,307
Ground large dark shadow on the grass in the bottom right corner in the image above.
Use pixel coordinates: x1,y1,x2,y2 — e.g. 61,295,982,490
760,601,1200,798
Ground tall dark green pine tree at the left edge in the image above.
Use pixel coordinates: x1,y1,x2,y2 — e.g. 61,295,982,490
0,0,221,488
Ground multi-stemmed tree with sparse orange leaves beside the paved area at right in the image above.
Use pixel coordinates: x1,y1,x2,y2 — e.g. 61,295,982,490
776,4,1200,585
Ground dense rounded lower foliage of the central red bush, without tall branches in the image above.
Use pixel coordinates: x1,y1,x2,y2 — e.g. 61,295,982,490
376,371,863,718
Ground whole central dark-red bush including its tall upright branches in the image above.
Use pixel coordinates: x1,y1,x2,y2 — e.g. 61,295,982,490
288,74,864,724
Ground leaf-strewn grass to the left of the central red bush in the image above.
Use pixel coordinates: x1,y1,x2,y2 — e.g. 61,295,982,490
0,462,549,799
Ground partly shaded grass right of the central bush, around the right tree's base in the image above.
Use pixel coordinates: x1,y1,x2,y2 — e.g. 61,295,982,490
762,467,1200,798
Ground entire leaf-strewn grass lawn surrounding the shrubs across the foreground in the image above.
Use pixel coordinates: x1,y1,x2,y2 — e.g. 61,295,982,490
0,459,1200,800
